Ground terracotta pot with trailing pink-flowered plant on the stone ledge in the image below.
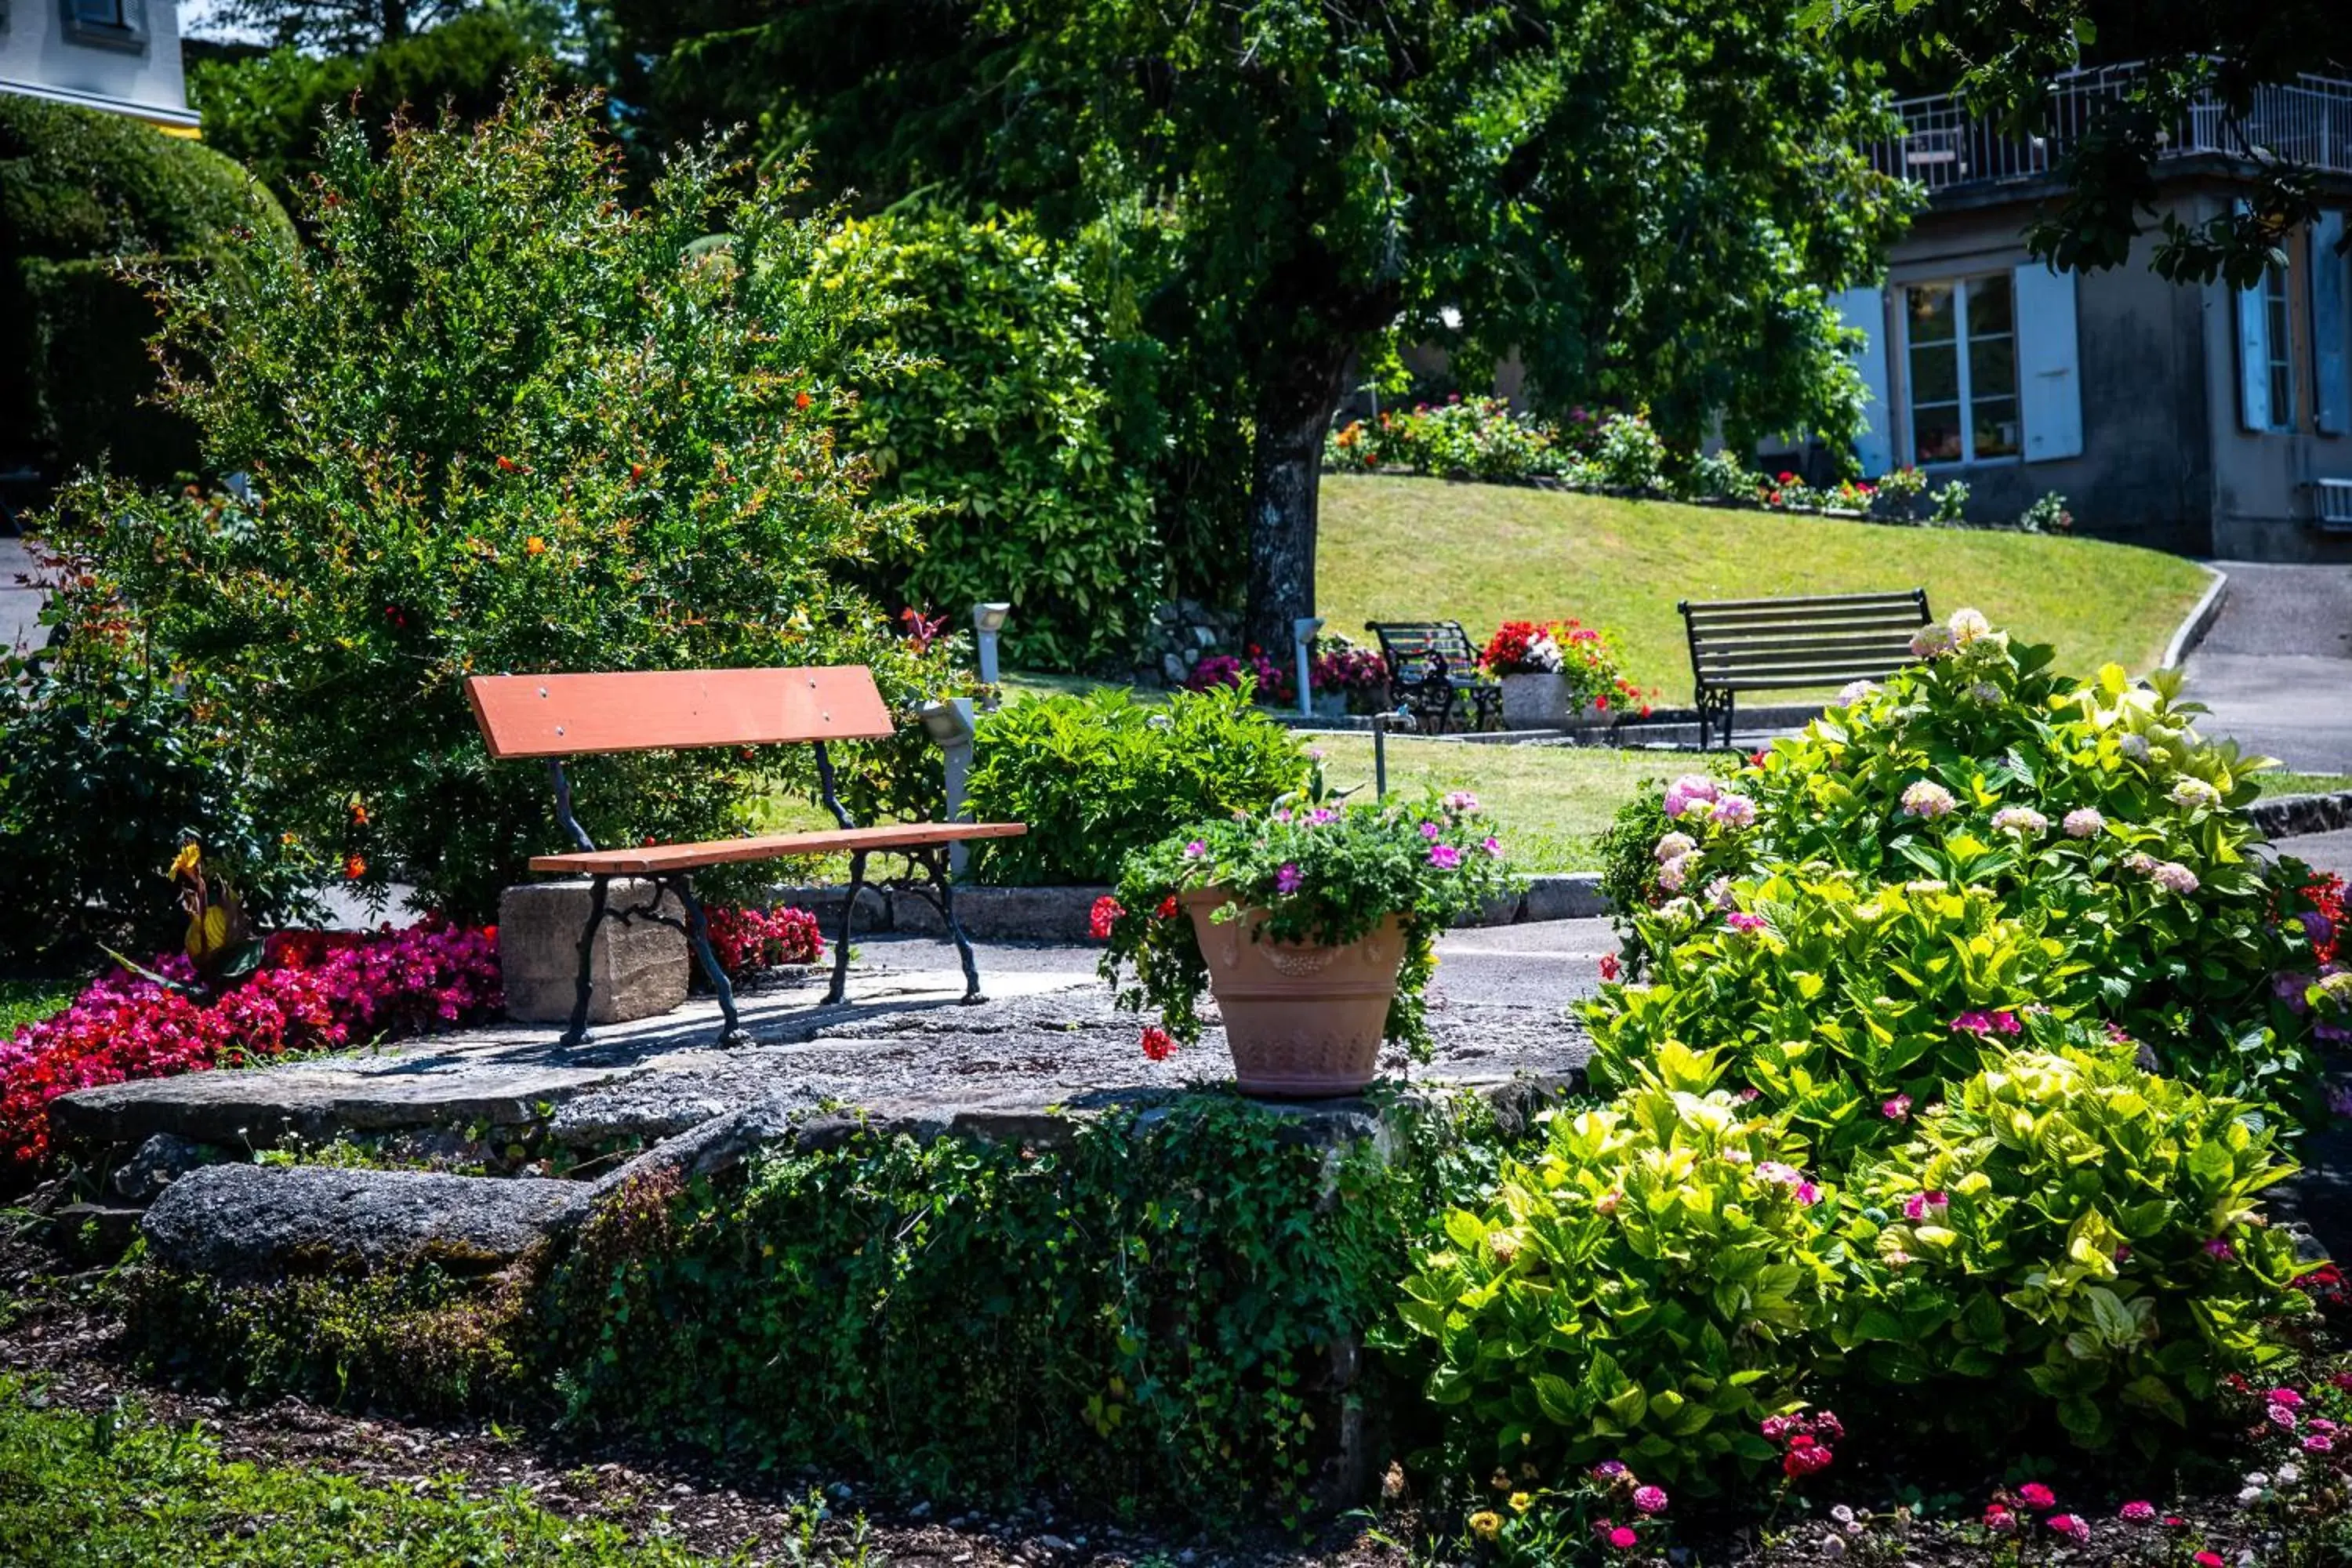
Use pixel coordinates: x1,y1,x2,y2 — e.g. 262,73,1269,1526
1094,792,1503,1098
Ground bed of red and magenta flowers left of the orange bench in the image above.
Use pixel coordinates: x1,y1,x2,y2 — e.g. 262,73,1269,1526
0,919,503,1175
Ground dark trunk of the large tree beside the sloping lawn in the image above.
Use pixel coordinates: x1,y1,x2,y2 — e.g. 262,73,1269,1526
1242,341,1348,670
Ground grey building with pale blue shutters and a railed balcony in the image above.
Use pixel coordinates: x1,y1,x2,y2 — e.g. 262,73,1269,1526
1839,66,2352,571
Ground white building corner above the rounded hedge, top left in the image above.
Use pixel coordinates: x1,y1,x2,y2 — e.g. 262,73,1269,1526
0,0,198,136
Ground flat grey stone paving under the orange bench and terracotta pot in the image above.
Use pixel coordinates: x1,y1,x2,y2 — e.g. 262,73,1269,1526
52,968,1588,1166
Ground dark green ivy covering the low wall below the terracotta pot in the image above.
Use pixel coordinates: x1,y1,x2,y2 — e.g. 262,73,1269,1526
550,1095,1491,1519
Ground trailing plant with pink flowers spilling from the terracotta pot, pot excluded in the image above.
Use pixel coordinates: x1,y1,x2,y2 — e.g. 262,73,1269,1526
1094,792,1503,1053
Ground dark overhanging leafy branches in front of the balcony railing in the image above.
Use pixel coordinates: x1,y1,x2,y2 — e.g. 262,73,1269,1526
1806,0,2352,287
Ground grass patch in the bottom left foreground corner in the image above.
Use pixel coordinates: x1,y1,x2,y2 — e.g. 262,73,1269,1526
0,1375,739,1568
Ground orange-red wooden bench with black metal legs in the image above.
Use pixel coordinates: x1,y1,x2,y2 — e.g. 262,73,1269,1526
466,666,1028,1046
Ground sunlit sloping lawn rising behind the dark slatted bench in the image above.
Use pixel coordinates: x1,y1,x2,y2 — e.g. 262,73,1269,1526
1315,475,2206,706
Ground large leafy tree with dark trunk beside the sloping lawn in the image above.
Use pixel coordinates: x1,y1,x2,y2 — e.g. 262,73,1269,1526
616,0,1903,644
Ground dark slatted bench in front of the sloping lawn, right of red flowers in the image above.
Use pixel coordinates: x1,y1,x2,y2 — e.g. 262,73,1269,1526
1675,588,1926,750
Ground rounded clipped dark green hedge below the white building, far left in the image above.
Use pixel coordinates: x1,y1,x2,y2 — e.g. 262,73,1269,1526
0,94,292,485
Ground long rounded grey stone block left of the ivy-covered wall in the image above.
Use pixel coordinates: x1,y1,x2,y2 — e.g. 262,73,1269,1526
139,1166,590,1279
